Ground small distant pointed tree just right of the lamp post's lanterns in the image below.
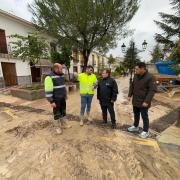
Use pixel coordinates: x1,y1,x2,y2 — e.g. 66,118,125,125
151,43,164,63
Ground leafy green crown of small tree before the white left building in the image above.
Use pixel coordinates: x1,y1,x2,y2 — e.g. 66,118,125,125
9,33,49,64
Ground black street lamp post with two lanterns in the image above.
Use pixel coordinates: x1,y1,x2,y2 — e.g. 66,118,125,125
121,40,148,85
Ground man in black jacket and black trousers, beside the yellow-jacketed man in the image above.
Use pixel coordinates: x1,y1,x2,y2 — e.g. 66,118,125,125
97,69,118,129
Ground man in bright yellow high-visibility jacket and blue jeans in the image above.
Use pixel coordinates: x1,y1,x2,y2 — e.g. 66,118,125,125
78,66,97,126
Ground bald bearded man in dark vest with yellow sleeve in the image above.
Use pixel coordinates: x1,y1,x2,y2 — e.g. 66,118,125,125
44,63,70,134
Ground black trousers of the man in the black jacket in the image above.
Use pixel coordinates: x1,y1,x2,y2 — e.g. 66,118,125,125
100,103,116,124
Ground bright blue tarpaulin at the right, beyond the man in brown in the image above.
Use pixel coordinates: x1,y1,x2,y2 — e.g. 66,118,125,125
156,60,176,75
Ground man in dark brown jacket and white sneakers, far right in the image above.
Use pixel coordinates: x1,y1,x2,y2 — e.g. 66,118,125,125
128,62,156,138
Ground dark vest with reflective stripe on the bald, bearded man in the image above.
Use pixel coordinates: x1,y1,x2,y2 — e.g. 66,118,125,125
49,72,66,99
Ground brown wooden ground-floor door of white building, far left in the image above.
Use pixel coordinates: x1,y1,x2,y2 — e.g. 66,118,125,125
1,62,17,86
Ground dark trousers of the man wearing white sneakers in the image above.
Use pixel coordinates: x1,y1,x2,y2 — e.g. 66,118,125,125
133,106,149,132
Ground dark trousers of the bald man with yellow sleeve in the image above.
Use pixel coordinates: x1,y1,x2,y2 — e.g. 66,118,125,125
53,98,66,120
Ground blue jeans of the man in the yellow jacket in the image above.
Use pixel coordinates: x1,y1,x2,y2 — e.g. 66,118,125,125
81,95,93,116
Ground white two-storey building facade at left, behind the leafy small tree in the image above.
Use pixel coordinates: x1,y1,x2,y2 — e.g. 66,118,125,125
0,10,53,88
